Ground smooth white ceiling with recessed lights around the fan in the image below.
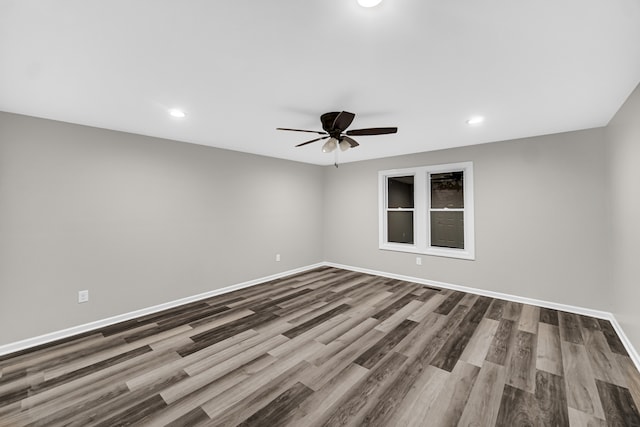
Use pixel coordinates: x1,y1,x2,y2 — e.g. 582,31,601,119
0,0,640,164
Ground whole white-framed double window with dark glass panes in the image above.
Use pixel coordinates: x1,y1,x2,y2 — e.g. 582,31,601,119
379,162,475,259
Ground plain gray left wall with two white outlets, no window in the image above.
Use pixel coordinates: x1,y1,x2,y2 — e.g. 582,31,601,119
0,113,323,345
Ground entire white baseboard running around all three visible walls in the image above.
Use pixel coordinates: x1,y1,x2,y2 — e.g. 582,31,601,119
0,262,640,371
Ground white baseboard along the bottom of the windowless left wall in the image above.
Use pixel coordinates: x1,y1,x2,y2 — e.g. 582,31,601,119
0,263,324,356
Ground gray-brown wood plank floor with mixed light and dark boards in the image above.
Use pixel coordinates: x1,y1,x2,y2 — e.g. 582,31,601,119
0,267,640,427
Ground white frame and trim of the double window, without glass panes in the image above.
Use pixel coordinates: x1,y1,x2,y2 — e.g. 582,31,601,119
378,162,475,260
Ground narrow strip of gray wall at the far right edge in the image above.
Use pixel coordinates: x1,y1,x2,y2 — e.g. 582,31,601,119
606,82,640,350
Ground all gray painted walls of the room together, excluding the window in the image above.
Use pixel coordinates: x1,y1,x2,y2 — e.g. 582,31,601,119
0,97,640,354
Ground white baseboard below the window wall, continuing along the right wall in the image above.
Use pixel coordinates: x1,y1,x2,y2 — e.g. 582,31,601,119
323,262,640,371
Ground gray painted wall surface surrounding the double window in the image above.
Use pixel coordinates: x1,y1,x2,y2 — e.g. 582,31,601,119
324,128,612,310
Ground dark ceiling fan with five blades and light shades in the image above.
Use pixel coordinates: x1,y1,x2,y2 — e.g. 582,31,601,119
277,111,398,153
